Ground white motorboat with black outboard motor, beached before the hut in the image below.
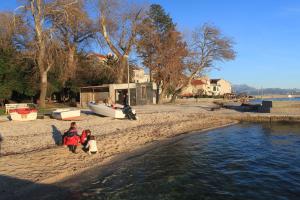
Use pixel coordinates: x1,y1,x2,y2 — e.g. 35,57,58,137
88,102,136,120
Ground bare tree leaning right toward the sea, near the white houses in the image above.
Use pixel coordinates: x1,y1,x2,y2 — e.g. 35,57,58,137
171,24,236,102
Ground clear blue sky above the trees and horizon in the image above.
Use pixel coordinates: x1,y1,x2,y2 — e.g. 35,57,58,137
0,0,300,88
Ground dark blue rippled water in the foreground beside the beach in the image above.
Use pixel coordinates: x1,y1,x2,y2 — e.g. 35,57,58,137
65,124,300,200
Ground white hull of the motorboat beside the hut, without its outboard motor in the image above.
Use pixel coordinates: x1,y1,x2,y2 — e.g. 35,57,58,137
88,103,135,119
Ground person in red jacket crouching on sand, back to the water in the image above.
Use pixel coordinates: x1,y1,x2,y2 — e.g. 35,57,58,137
63,124,80,153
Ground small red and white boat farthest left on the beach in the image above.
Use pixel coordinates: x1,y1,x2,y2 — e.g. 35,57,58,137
9,108,37,121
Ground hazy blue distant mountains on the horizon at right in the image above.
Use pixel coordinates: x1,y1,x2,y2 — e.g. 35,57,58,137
232,84,300,95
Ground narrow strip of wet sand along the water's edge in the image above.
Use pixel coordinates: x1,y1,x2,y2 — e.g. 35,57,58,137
2,122,239,199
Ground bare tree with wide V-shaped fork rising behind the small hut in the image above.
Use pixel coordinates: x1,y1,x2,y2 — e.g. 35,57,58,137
98,0,143,83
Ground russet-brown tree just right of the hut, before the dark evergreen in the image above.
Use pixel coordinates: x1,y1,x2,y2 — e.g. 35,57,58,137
138,23,188,103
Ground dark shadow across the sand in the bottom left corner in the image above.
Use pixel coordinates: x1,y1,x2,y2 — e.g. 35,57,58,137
0,175,78,200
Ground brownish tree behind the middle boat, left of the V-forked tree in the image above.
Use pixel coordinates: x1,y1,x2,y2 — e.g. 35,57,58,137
51,0,95,85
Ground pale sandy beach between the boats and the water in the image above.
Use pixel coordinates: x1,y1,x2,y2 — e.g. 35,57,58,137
0,102,298,197
